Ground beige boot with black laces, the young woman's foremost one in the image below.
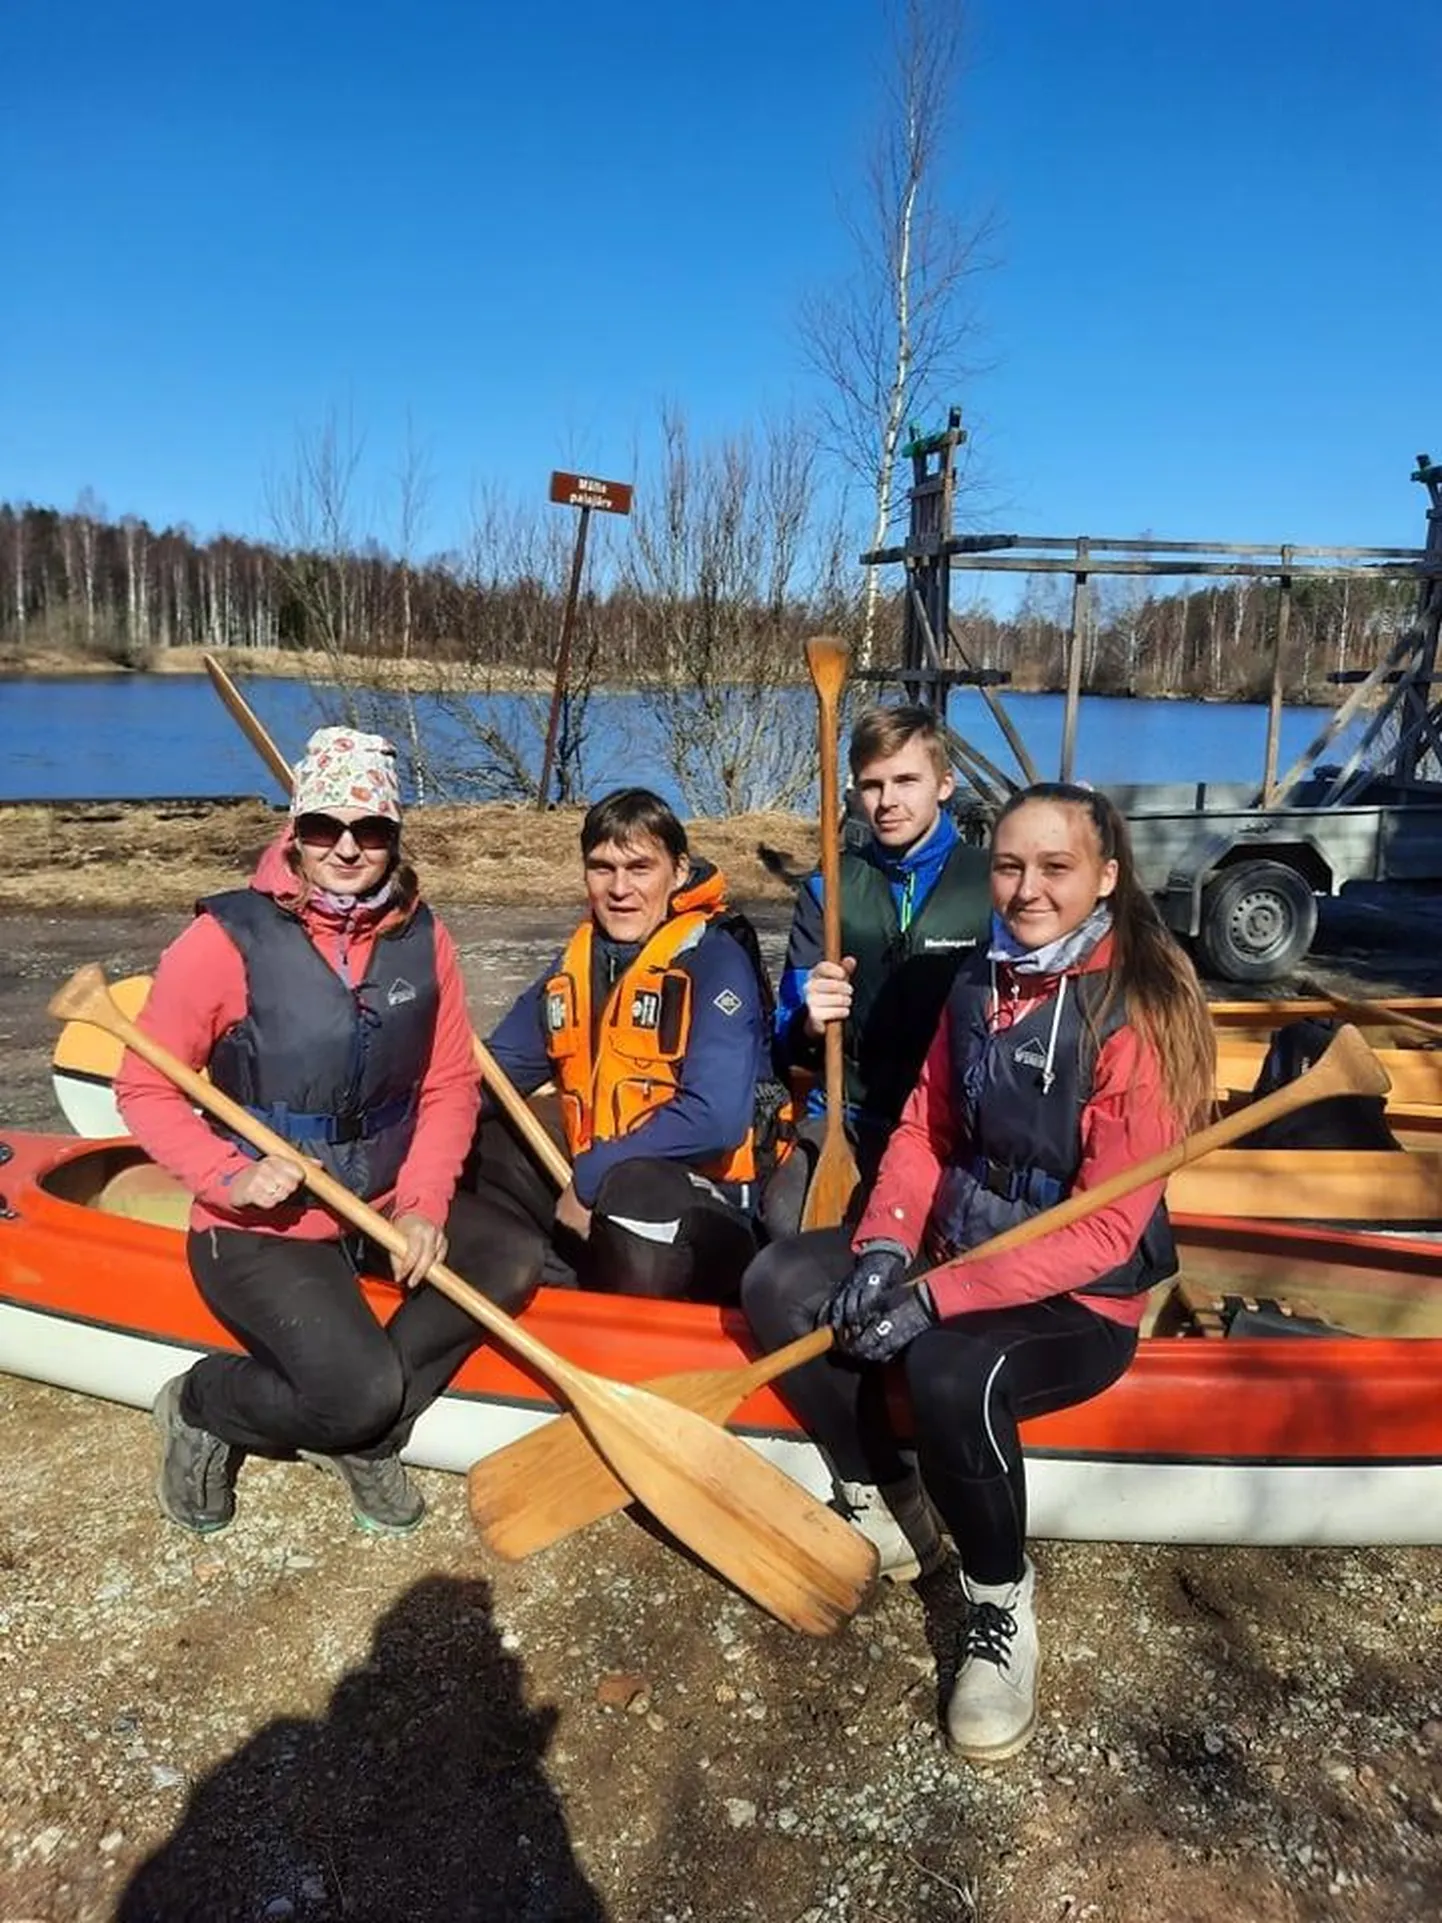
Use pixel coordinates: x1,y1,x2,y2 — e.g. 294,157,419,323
946,1561,1040,1763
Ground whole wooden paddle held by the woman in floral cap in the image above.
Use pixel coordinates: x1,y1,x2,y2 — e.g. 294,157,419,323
50,965,877,1636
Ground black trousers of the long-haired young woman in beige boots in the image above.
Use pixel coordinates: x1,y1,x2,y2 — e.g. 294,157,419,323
742,1229,1136,1585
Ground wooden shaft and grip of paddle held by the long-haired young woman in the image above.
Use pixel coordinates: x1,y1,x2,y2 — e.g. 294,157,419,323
738,1027,1392,1394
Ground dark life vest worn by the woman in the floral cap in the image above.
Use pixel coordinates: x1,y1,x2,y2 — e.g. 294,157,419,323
198,888,440,1200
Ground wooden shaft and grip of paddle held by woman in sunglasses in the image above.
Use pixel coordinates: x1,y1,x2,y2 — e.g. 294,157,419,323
50,962,575,1388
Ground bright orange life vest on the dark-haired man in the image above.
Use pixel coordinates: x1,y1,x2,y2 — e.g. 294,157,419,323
542,873,756,1183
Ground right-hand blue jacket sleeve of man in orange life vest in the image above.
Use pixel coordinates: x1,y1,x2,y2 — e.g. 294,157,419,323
575,929,767,1208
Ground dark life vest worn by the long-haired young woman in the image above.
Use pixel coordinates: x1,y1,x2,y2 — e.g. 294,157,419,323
927,958,1177,1296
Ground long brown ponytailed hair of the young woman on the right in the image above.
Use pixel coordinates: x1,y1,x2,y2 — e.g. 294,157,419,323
996,781,1217,1129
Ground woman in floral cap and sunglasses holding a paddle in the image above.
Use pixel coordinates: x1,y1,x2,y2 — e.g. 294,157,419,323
115,727,515,1533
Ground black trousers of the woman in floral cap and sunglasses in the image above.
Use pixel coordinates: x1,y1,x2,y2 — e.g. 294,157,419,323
181,1192,525,1456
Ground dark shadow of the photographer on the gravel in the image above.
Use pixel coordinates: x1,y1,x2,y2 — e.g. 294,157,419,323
115,1577,606,1923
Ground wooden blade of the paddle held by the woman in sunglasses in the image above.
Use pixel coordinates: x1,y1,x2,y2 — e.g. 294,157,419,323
573,1383,877,1636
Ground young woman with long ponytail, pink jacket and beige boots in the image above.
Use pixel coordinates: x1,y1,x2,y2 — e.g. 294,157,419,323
742,783,1215,1761
